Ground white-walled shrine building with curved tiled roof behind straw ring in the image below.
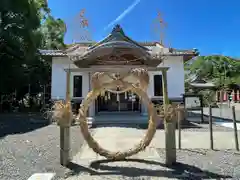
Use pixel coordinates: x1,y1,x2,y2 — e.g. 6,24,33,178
40,25,198,116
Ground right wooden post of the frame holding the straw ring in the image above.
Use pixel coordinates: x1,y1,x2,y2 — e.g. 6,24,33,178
162,69,176,165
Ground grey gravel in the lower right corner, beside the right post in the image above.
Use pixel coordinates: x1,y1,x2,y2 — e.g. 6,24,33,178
158,149,240,180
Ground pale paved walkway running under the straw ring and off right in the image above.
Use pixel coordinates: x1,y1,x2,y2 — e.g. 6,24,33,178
67,127,240,180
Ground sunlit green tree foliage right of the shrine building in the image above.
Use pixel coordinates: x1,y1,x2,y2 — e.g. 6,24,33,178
185,56,240,89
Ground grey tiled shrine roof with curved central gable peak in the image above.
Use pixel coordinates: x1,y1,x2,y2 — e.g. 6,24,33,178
40,25,198,59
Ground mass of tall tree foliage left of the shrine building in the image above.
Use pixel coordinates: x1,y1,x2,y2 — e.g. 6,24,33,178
0,0,66,100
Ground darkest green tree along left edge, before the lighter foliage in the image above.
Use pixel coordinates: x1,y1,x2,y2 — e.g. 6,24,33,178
0,0,40,92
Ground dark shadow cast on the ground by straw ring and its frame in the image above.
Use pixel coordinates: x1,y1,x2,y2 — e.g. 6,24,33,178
65,159,232,180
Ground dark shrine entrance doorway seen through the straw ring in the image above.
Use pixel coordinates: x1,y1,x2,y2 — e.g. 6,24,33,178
96,92,141,113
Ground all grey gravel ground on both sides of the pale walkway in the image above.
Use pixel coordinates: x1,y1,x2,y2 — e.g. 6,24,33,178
0,115,240,180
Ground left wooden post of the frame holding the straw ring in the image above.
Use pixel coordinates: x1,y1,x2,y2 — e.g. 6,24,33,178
60,70,71,166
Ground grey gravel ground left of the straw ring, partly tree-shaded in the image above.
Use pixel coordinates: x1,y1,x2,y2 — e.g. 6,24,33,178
0,116,88,180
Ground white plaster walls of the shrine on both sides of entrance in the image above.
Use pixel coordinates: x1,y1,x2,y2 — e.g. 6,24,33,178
51,56,184,115
